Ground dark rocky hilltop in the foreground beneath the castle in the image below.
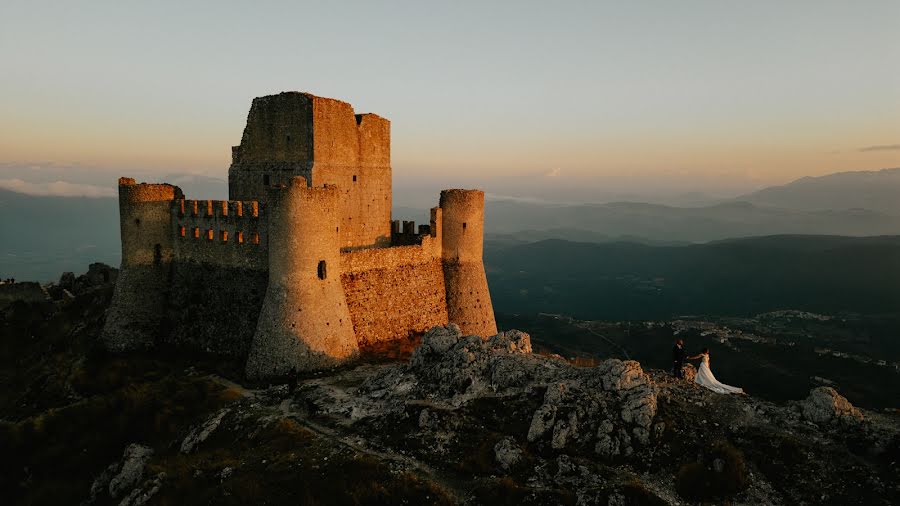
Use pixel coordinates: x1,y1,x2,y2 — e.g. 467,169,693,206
0,266,900,505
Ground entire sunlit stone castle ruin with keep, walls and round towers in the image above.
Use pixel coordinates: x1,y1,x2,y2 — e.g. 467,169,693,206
102,92,497,378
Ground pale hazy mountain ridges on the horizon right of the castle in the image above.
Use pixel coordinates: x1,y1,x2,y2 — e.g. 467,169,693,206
395,169,900,244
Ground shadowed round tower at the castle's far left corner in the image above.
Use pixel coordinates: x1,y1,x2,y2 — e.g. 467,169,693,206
102,177,183,352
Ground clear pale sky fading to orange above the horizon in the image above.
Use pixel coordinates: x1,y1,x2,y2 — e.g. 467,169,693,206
0,0,900,200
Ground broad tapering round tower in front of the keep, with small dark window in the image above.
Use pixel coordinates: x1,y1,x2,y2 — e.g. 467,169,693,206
247,176,359,378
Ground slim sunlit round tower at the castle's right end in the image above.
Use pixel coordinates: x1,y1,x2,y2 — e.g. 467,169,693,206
440,190,497,338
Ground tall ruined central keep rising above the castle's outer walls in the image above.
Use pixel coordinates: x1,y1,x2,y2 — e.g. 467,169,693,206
228,92,391,249
